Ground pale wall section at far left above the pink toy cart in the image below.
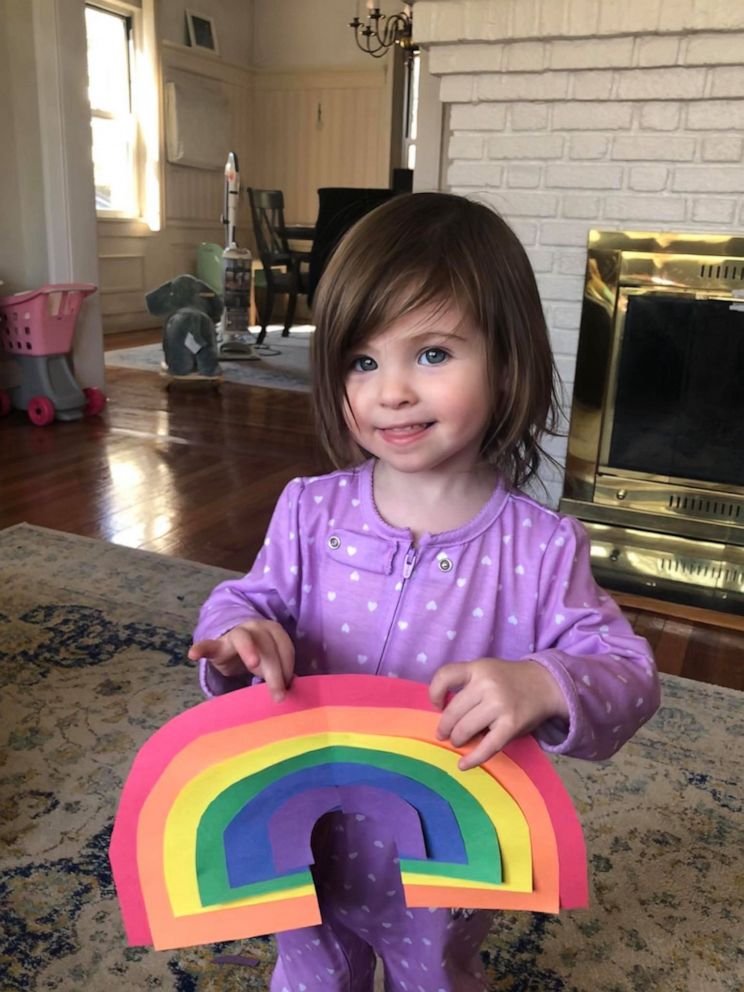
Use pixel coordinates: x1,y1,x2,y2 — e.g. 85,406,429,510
0,0,104,396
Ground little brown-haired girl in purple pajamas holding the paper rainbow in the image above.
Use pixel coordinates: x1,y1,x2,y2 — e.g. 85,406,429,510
189,193,659,992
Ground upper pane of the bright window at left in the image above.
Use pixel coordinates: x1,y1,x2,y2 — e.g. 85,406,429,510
85,7,130,116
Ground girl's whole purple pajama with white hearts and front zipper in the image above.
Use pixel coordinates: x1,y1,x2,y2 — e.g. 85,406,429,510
194,461,659,992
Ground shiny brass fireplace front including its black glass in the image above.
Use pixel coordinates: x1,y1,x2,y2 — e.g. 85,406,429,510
561,231,744,613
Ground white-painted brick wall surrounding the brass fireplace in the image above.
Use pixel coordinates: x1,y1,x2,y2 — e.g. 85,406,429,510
414,0,744,503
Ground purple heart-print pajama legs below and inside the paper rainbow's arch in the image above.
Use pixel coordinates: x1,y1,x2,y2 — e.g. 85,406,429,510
271,813,493,992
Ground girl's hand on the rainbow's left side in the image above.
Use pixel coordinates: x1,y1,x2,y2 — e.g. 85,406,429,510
188,620,294,703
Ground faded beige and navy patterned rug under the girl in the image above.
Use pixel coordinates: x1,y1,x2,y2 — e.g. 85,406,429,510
0,524,744,992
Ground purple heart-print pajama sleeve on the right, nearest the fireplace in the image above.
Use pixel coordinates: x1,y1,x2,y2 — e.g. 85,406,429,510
530,517,659,760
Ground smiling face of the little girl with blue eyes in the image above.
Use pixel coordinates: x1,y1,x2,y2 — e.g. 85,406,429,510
345,306,492,472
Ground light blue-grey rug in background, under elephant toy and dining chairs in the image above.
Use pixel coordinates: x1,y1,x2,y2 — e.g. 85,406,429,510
104,324,315,392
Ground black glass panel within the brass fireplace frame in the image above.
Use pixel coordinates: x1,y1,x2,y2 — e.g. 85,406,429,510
609,294,744,486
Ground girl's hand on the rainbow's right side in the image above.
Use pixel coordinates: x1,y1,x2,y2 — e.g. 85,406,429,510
429,658,568,771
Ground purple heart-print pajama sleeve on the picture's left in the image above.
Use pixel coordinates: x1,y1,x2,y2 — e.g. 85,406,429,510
194,479,304,696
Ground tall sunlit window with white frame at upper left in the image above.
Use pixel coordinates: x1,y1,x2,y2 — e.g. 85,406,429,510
85,0,160,229
